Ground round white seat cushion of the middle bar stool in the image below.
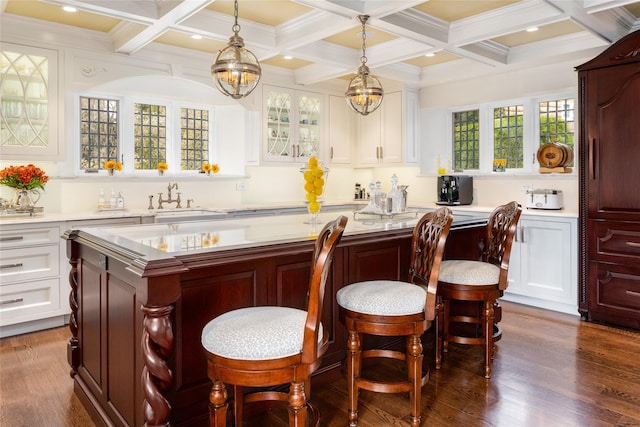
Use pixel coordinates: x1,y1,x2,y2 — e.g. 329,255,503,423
336,280,427,316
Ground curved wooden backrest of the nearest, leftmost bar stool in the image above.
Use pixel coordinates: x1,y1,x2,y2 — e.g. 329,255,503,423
302,215,347,364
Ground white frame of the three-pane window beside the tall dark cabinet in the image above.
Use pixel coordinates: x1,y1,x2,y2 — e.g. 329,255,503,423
443,91,579,176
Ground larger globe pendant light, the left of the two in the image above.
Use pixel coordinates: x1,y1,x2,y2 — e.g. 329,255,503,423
211,0,261,99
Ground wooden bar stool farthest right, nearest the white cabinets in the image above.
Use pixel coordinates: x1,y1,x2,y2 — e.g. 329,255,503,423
436,202,522,378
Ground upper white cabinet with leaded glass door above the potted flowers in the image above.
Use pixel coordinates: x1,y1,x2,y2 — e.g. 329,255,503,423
0,43,58,160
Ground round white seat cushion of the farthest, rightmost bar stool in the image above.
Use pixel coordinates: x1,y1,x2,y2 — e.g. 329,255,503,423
438,260,500,285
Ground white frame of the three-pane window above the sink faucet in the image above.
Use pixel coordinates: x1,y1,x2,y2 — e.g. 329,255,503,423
73,91,218,177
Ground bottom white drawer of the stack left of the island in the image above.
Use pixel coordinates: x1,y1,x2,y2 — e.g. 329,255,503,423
0,279,63,326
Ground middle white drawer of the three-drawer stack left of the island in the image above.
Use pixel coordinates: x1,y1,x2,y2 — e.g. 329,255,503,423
0,244,60,286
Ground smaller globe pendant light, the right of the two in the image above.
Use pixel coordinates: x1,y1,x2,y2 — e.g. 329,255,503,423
344,15,384,116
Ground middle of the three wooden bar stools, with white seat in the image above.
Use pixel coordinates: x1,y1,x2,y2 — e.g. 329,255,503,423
336,208,453,426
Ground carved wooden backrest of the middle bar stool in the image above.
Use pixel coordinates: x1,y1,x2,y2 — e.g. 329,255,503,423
408,207,453,320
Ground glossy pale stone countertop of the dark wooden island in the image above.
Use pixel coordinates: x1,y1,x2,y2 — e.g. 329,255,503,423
69,209,488,259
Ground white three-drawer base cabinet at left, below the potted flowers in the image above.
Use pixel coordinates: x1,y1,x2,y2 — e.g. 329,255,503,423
0,223,65,336
